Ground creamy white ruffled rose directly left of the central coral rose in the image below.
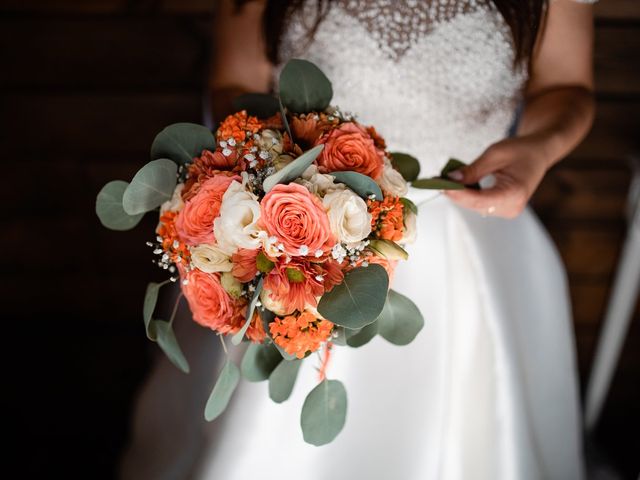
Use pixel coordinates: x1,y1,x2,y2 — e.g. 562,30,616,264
213,181,260,252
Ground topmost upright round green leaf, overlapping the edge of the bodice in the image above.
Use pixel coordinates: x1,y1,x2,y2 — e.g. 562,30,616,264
278,58,333,113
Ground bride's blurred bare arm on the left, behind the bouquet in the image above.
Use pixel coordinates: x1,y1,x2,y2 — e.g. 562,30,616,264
209,0,272,119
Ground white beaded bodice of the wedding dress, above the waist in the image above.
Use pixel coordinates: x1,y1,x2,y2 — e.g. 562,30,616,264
281,0,596,175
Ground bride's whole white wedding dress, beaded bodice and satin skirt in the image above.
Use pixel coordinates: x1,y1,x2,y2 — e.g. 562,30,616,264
121,0,596,480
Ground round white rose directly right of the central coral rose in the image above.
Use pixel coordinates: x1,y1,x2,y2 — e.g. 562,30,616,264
322,189,371,245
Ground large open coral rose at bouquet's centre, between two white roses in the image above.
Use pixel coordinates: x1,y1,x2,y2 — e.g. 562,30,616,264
260,183,335,256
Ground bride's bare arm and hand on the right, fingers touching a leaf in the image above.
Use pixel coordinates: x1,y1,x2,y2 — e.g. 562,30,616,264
447,0,594,218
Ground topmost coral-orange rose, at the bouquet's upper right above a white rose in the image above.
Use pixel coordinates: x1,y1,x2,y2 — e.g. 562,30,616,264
316,122,384,179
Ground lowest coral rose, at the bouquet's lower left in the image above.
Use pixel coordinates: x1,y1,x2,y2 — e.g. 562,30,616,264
182,269,237,333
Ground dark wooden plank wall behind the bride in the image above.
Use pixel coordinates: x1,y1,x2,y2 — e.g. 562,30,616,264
0,0,640,479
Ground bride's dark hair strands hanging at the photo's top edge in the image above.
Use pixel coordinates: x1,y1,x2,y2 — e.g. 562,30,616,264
235,0,549,64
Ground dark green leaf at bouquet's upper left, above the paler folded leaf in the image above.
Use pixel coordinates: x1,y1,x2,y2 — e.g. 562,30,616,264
151,123,216,164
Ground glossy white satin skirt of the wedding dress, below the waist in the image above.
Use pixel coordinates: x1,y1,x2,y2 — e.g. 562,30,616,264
123,192,584,480
